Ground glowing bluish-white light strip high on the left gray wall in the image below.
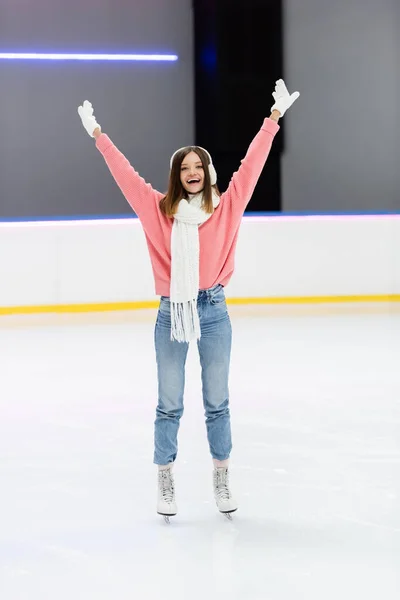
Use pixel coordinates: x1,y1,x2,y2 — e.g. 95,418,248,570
0,52,178,61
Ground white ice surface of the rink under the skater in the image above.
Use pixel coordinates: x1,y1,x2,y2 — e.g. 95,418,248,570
0,305,400,600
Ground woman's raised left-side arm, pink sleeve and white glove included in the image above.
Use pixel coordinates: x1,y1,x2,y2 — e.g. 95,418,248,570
78,100,163,218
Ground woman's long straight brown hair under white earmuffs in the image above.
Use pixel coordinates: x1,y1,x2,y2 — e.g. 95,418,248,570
160,146,221,217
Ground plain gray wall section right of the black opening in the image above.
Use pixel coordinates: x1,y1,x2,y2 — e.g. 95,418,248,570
283,0,400,212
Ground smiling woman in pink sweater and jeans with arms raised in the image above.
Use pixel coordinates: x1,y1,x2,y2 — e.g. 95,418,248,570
78,79,299,517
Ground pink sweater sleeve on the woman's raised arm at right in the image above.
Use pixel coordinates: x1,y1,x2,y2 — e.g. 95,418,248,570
222,118,280,215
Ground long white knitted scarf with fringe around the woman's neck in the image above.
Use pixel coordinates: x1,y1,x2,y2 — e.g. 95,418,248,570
170,192,220,342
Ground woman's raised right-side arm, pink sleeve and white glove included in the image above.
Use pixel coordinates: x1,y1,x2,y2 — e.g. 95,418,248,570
223,79,300,214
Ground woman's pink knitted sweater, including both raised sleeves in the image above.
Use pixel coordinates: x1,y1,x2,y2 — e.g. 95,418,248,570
96,119,279,296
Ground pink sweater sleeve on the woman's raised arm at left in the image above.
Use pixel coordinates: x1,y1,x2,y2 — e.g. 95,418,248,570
96,133,163,218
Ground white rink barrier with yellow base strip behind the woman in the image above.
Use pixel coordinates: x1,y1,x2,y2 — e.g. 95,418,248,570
0,214,400,315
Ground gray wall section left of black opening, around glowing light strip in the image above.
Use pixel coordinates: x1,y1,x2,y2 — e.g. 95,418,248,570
0,0,194,217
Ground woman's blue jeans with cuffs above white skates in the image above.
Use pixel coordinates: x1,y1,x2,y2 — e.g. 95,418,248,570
154,284,232,465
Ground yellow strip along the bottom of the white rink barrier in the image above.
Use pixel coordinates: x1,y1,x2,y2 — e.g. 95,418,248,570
0,294,400,315
